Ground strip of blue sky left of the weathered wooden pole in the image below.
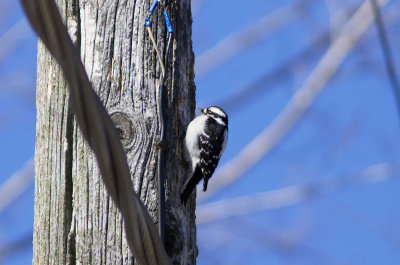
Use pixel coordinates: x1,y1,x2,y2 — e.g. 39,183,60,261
0,0,37,264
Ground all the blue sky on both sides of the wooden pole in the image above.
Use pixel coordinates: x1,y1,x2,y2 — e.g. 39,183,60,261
0,0,400,265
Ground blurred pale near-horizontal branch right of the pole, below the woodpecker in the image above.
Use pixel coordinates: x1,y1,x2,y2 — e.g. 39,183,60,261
196,163,400,224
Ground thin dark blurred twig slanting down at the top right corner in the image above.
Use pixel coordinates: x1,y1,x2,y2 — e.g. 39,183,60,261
371,0,400,121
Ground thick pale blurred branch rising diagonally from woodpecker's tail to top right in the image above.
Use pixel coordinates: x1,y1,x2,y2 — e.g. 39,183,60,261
198,0,387,201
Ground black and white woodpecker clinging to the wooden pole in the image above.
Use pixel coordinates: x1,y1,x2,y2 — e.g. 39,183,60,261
181,106,228,203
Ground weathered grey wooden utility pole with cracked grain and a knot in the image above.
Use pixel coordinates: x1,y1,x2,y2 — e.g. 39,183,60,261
33,0,197,265
